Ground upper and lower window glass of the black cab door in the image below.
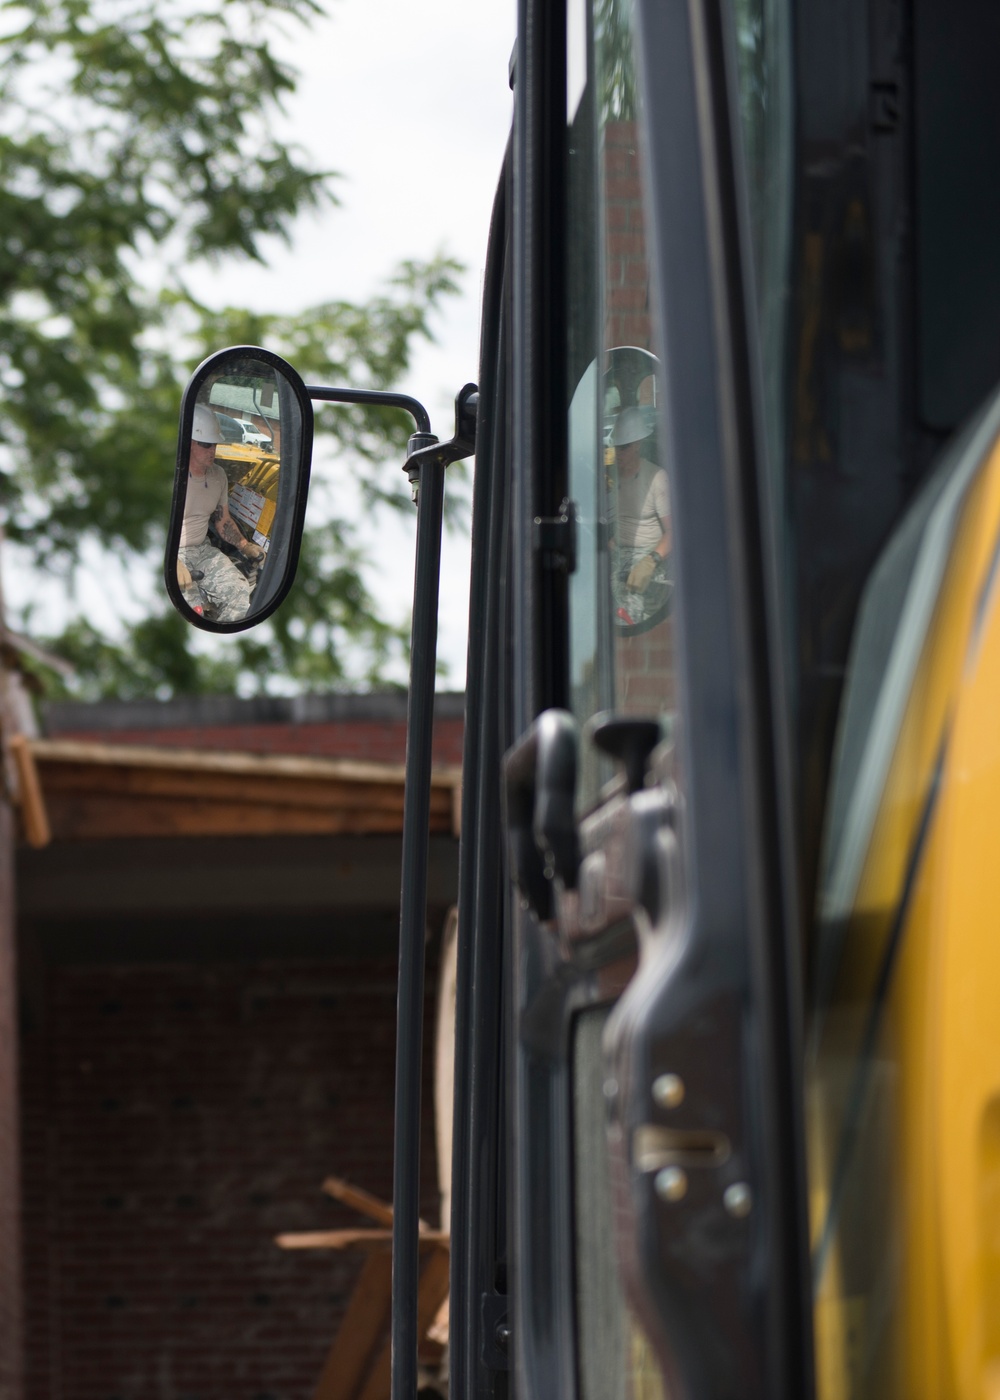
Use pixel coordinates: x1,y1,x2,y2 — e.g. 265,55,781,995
566,0,672,1400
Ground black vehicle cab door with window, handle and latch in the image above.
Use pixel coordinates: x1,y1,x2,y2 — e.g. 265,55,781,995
504,0,812,1400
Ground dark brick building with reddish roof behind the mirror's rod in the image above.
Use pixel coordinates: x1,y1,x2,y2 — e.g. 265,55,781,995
12,696,462,1400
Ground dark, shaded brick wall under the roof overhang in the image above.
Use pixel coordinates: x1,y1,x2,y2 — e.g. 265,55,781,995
22,960,437,1400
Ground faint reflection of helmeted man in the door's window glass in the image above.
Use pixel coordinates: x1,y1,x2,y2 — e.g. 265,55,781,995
611,407,671,594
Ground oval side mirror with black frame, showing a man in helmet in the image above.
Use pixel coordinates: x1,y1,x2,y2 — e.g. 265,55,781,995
164,346,312,631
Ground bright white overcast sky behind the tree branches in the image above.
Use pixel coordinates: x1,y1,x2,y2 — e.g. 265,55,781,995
6,0,515,689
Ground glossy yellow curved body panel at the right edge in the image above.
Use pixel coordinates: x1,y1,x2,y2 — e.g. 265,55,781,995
808,431,1000,1400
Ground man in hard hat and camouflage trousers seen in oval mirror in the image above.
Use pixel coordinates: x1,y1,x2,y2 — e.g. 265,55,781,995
176,403,265,622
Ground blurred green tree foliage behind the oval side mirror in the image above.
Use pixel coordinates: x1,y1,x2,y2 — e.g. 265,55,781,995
0,0,459,694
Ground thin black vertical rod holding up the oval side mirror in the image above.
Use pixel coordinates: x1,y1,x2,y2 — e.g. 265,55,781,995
391,458,445,1400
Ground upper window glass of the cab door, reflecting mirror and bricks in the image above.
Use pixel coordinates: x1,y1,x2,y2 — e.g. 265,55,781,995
566,0,674,806
